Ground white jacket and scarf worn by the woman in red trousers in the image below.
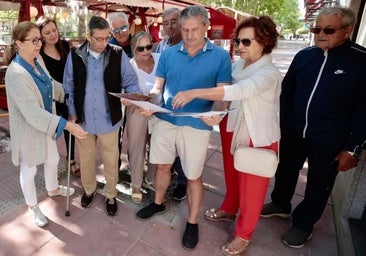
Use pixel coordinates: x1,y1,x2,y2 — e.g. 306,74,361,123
223,54,282,147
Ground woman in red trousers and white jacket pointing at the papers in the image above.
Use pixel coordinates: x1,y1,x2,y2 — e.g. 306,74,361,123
172,16,282,255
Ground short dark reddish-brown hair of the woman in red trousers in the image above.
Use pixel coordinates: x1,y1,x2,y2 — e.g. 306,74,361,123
234,15,279,54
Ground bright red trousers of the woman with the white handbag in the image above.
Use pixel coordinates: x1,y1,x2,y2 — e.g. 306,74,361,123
220,116,278,240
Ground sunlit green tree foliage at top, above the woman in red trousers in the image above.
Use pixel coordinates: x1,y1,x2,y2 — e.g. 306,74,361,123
198,0,302,33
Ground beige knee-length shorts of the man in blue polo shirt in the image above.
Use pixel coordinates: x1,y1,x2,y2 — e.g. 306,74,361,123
150,117,211,180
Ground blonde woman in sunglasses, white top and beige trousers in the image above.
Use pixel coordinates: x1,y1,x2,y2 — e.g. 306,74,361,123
125,31,160,204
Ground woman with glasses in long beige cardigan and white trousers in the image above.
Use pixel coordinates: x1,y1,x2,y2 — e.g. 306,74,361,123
5,21,87,227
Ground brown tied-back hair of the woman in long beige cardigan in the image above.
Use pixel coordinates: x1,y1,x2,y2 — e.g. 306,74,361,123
5,21,39,64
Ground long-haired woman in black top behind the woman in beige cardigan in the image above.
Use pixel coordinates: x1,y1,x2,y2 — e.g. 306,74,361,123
36,16,80,177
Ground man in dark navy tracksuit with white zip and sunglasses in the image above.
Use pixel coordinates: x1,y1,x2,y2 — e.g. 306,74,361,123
261,7,366,248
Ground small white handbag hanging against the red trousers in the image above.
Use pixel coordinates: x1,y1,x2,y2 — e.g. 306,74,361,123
234,145,278,178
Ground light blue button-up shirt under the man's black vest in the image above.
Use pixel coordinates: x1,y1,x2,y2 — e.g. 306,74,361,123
63,43,140,134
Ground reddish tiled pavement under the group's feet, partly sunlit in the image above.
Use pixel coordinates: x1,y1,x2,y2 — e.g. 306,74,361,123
0,132,338,256
